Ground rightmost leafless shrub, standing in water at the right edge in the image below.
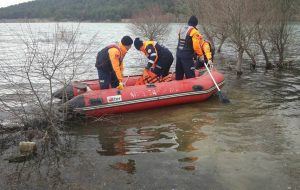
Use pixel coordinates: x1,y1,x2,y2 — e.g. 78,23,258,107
255,0,298,69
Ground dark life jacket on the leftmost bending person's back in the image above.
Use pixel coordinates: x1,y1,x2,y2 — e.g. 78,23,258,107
95,44,124,72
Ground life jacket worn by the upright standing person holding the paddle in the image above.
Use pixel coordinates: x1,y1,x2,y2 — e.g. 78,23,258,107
177,26,194,52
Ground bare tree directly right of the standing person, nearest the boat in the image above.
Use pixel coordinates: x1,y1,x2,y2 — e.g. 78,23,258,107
184,0,252,75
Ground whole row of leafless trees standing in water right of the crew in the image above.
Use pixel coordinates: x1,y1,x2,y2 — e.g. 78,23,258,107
187,0,299,74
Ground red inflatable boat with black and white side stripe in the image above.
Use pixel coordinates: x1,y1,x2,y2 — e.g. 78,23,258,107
61,69,224,116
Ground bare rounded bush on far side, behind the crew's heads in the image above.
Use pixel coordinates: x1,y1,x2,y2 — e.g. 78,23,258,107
129,5,171,41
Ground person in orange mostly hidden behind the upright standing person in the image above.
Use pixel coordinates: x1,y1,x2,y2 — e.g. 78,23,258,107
195,40,215,69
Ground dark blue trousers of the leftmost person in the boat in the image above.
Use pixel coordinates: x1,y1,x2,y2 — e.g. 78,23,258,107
97,68,119,89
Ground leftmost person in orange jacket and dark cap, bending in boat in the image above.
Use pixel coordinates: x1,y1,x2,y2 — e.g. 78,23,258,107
95,36,133,90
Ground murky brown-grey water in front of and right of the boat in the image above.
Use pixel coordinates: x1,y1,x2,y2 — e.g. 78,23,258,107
0,24,300,190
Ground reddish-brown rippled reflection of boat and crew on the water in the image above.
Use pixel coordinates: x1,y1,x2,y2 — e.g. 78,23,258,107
72,104,213,156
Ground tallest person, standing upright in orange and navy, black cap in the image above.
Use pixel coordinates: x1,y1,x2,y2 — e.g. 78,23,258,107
175,16,204,80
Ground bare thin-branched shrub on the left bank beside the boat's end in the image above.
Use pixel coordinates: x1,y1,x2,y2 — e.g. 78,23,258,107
0,24,95,152
